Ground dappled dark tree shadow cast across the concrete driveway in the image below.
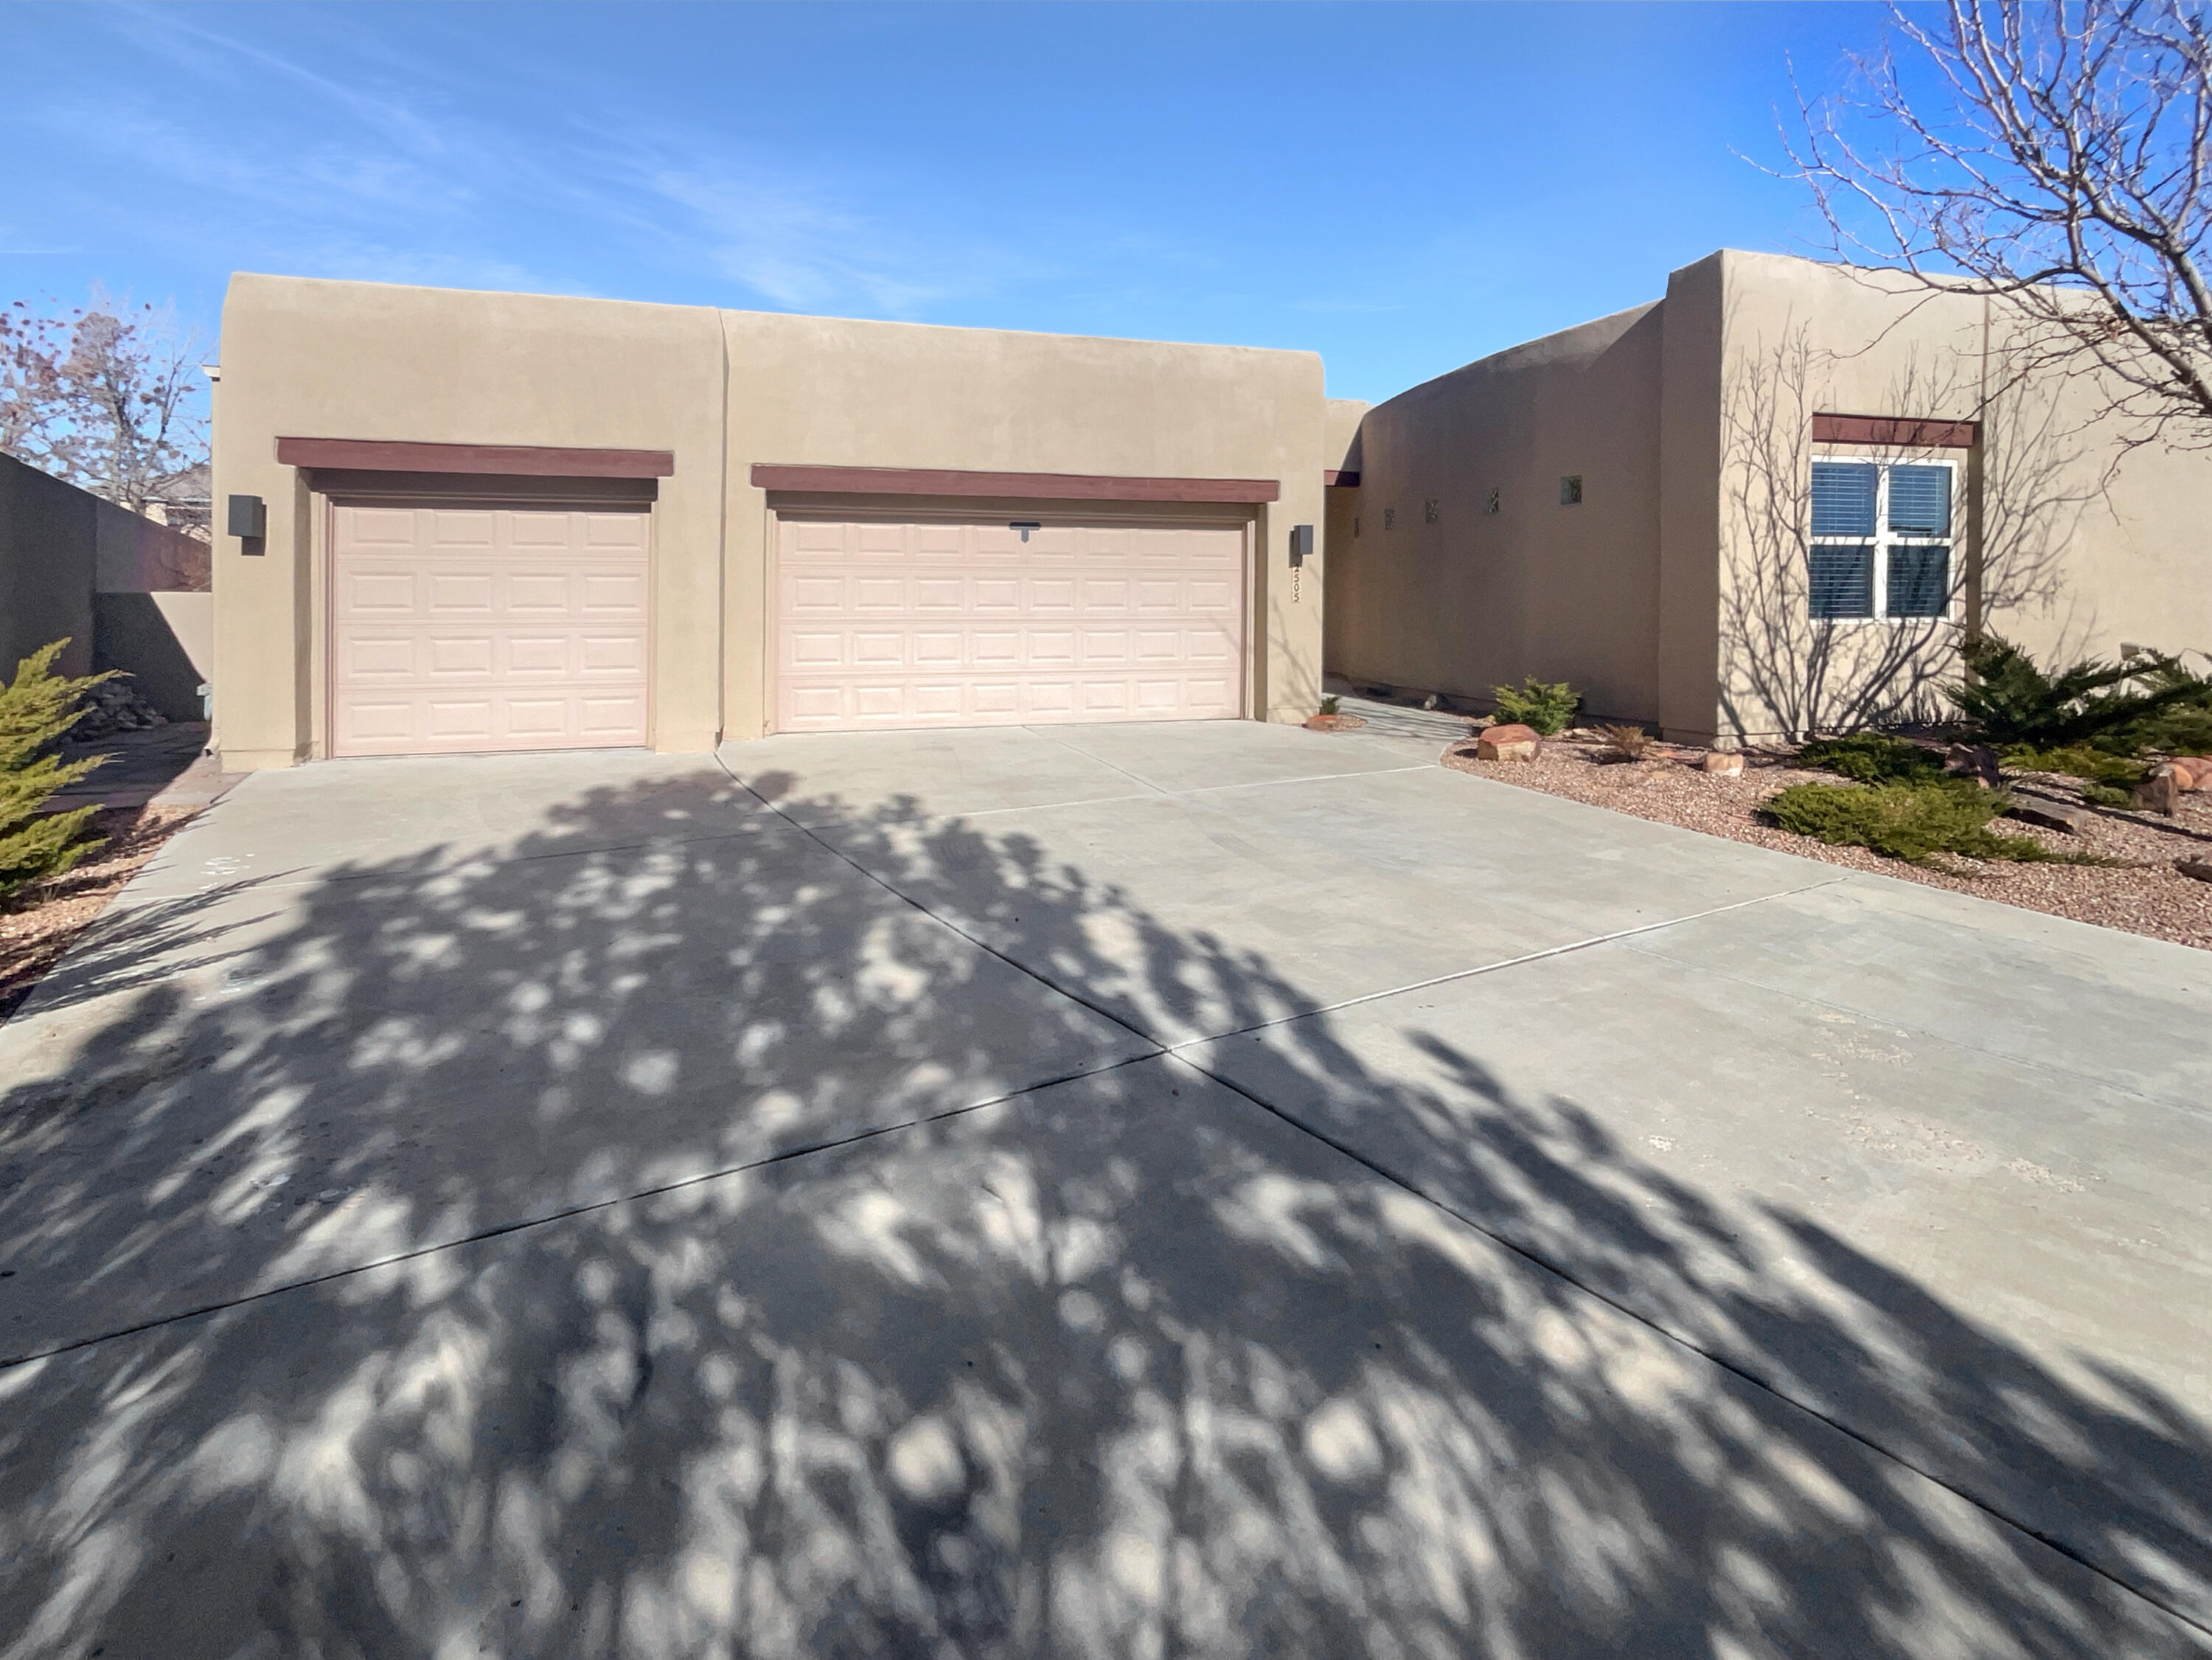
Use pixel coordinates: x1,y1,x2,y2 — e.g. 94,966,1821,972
0,781,2212,1660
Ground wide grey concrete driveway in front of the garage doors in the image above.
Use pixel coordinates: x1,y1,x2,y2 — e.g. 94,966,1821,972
0,723,2212,1660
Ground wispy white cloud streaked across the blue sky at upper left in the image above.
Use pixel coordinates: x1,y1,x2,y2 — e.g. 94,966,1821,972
35,7,1064,319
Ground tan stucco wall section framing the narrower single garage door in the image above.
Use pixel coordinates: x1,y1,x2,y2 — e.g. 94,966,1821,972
215,274,723,768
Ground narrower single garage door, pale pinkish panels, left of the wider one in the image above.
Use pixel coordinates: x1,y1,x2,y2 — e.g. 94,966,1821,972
330,507,650,754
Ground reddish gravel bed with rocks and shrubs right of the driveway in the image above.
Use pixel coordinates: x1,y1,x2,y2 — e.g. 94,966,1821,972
1442,728,2212,950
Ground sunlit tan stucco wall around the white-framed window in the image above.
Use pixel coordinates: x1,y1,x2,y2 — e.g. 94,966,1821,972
1708,252,2212,737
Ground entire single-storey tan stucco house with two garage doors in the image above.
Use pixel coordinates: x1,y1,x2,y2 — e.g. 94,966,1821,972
215,252,2212,768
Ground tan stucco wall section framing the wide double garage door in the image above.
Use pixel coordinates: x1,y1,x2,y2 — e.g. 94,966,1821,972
721,312,1323,737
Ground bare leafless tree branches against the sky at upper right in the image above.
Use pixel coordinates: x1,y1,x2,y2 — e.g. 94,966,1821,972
1792,0,2212,445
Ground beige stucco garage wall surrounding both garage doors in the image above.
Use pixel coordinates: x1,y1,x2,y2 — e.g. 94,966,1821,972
215,274,1327,768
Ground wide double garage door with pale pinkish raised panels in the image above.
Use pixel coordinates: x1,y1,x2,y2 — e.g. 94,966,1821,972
776,515,1245,732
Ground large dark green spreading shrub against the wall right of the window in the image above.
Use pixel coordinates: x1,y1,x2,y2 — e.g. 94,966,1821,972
1947,635,2212,754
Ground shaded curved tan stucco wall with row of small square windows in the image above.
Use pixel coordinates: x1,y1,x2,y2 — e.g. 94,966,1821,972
1329,305,1661,719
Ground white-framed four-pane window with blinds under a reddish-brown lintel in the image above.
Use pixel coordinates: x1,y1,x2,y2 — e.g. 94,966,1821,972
1807,458,1958,622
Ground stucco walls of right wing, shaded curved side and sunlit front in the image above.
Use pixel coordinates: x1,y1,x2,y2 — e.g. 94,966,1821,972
1329,252,2212,743
